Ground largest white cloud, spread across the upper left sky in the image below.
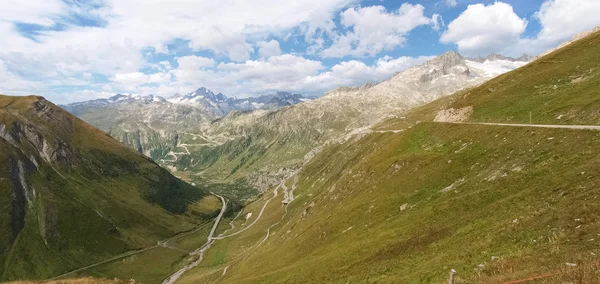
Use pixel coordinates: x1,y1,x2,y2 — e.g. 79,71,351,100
0,0,354,84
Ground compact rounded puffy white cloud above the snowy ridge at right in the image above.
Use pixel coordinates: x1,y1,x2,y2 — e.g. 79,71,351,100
440,2,527,55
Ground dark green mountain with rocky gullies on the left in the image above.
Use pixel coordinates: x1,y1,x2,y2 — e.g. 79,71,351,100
0,96,218,281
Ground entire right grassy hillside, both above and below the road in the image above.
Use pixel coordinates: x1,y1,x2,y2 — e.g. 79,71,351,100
175,28,600,283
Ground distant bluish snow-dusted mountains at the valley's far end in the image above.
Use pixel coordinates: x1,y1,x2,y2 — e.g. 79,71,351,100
61,87,311,164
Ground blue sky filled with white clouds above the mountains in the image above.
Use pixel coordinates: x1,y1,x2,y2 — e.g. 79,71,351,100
0,0,600,103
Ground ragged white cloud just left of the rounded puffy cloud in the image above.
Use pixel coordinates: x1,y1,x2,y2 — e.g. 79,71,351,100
321,3,434,57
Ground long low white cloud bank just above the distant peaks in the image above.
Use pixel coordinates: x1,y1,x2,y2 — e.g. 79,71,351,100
164,54,432,96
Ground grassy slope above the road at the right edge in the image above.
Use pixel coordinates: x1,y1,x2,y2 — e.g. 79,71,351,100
418,29,600,125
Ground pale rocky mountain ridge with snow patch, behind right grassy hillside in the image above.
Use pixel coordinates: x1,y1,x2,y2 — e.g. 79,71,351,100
163,52,526,190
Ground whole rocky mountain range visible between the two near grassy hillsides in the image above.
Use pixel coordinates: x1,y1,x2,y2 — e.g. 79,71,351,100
63,52,529,191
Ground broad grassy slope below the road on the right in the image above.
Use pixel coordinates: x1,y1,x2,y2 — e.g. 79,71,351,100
191,123,600,283
